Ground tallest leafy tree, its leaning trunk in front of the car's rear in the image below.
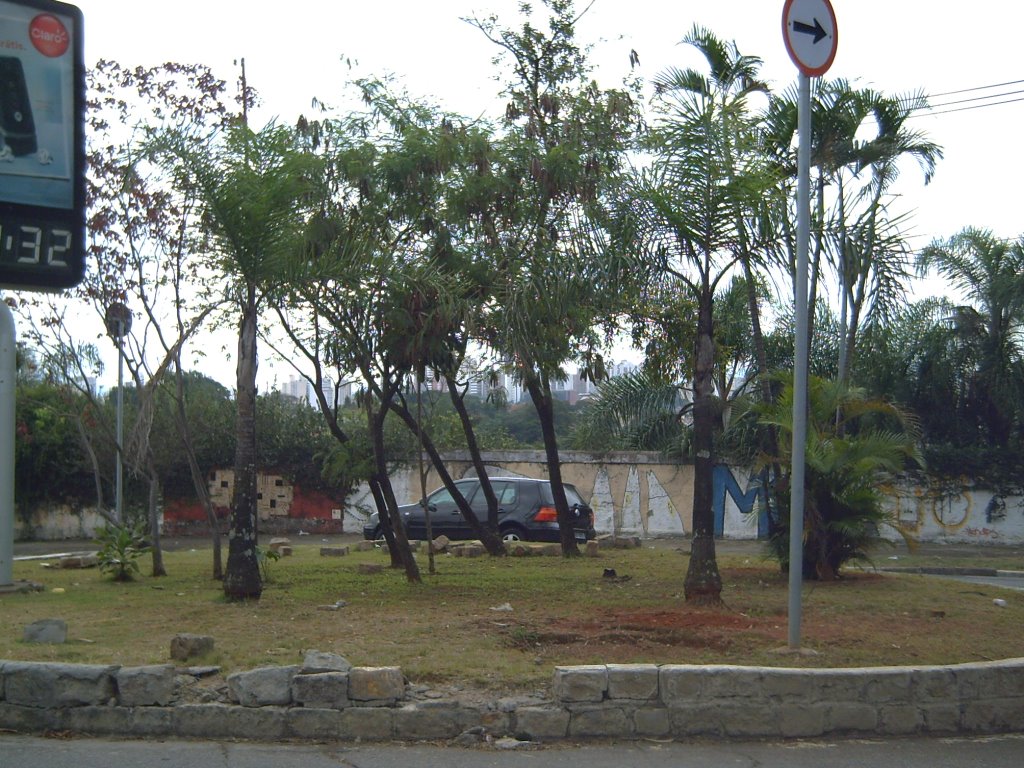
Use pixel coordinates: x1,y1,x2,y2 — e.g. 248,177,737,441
464,0,637,555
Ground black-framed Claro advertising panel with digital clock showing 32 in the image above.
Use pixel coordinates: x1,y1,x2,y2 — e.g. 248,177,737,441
0,0,85,291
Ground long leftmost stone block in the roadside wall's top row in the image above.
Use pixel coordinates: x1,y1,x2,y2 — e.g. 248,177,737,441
3,662,118,709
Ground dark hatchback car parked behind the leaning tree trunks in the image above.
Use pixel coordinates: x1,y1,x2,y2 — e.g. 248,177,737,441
362,477,597,542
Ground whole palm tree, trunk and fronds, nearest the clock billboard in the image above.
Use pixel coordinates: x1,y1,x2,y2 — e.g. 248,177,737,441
147,123,315,600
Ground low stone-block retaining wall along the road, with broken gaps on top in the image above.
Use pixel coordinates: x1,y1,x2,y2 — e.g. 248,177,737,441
0,658,1024,741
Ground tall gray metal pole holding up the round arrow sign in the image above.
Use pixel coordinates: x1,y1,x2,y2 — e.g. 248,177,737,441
790,73,811,650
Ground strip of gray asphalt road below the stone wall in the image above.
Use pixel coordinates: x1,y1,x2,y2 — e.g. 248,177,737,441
0,734,1024,768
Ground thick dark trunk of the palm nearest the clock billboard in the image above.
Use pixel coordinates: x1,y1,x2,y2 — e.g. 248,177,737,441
224,283,263,600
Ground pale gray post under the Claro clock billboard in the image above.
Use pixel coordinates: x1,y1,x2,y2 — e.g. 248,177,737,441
0,296,17,587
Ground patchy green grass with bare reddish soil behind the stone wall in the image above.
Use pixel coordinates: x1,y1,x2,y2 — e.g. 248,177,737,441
0,546,1024,691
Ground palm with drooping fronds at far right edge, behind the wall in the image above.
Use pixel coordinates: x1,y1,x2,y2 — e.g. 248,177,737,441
918,227,1024,445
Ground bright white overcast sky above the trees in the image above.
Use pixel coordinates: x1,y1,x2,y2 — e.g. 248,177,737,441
49,0,1024,381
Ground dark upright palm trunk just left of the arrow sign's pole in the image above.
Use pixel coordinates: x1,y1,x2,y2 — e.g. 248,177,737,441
683,280,722,605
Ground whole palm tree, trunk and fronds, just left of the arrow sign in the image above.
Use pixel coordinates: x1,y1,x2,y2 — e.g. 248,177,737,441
626,27,771,602
